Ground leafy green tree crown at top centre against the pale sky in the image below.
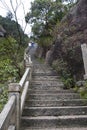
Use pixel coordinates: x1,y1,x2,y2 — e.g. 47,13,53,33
26,0,67,47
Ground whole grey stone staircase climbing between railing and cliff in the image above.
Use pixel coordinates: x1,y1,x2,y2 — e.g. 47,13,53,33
20,63,87,130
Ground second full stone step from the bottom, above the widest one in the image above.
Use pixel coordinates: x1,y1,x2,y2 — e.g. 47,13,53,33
23,106,87,116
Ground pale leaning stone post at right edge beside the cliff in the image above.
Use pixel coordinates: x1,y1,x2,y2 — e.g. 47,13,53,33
81,43,87,79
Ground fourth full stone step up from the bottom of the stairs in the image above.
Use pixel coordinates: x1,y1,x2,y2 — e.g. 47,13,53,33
27,93,80,101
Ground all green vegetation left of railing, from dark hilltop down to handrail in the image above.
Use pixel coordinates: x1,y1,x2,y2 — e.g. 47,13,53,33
0,16,29,111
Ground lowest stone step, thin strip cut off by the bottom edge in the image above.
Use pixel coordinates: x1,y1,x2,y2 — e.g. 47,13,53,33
21,127,87,130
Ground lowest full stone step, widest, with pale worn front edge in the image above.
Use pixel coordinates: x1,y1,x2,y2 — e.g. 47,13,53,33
21,115,87,128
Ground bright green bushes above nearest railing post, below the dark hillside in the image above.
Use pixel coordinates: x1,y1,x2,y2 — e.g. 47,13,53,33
0,36,24,82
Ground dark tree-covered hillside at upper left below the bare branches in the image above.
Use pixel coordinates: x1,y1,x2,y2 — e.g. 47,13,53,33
0,15,28,44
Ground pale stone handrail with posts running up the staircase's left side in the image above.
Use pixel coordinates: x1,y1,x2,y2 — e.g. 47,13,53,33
0,51,32,130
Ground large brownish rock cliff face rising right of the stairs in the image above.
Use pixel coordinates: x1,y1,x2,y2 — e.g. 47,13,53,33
52,0,87,79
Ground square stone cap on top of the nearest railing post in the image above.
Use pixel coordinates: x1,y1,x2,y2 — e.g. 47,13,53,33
8,83,21,92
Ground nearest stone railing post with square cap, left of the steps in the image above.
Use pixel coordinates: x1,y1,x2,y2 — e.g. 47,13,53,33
9,83,21,130
